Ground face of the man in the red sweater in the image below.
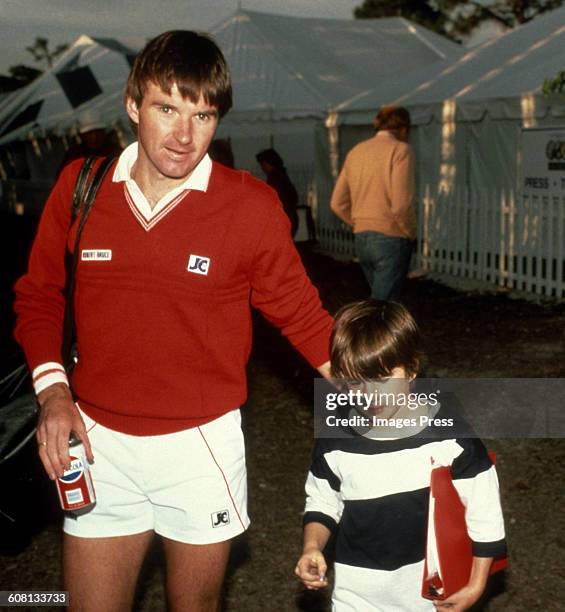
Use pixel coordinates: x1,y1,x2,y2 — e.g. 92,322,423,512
126,82,218,184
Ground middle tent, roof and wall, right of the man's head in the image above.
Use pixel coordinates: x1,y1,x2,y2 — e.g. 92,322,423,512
212,10,461,180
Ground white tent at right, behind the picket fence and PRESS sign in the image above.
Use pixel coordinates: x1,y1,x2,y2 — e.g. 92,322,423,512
337,7,565,198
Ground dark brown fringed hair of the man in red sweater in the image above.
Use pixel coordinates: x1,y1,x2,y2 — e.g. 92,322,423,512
125,30,232,117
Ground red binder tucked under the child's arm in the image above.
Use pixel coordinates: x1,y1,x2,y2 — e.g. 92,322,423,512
422,453,508,599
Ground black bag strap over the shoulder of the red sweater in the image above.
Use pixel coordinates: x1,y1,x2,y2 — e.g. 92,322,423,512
61,157,115,368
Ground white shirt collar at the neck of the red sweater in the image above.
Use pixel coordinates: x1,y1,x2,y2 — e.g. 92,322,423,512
112,142,212,221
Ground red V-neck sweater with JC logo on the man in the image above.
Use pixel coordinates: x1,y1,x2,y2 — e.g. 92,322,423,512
15,161,332,435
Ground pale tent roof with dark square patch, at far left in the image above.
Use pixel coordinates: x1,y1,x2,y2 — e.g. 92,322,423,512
0,35,135,144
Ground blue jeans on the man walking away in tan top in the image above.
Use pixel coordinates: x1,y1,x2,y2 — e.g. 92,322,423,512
354,232,412,300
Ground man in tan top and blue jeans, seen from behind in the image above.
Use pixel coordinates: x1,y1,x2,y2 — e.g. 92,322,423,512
330,106,416,300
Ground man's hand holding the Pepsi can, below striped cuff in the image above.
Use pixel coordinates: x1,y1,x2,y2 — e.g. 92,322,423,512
36,383,94,480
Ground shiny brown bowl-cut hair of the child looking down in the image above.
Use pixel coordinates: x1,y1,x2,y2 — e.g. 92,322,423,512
330,300,421,381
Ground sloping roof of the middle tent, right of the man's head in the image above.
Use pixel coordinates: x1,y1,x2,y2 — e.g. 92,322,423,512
212,10,462,119
